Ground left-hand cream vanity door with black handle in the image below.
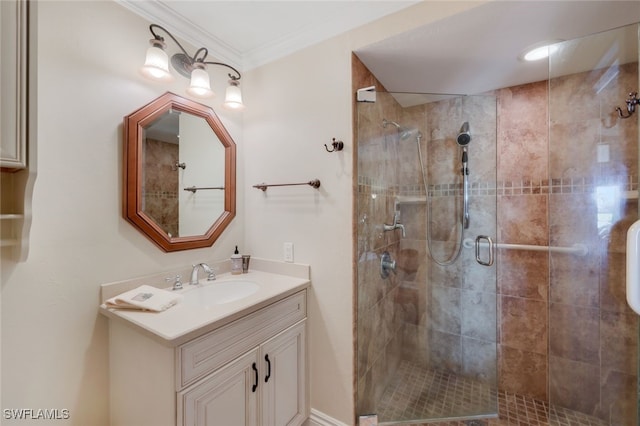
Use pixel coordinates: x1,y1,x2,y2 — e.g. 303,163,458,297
178,350,260,426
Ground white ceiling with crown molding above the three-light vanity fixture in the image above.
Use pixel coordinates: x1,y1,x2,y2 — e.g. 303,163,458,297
116,0,420,71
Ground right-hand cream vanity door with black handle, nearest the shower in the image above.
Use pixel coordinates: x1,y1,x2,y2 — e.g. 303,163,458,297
260,320,309,426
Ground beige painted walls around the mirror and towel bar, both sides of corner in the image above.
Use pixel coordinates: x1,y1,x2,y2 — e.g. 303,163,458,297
1,1,488,426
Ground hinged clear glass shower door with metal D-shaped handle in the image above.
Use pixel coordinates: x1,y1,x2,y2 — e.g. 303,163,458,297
356,92,497,424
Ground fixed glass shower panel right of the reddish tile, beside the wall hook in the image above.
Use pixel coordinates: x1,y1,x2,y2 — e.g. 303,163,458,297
549,25,640,425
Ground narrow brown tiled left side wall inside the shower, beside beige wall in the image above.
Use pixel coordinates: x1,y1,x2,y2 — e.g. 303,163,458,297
353,57,408,413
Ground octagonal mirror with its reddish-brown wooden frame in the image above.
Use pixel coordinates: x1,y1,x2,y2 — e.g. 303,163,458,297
123,92,236,252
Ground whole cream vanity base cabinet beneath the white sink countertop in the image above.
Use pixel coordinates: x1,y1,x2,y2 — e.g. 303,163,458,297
109,290,309,426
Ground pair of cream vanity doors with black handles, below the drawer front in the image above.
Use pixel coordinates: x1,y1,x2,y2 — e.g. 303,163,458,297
178,320,307,426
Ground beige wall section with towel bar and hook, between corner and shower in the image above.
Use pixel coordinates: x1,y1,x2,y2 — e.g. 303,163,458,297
243,2,484,424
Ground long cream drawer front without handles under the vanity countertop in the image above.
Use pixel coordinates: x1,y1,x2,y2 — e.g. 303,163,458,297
176,290,307,391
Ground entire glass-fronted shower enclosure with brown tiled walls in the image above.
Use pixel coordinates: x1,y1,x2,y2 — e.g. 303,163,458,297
354,25,640,425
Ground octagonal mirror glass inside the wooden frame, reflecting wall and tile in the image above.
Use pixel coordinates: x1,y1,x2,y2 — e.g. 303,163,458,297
142,110,225,237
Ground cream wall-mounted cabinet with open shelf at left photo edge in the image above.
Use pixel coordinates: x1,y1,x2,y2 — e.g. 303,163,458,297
0,0,37,261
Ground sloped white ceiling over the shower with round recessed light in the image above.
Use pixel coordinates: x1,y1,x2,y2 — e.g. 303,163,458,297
356,0,640,98
